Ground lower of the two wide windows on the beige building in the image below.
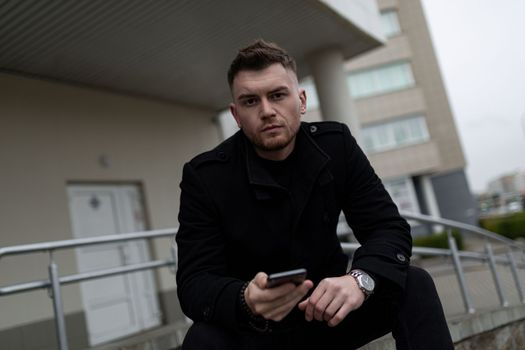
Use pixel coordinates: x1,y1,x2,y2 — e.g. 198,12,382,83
362,116,430,153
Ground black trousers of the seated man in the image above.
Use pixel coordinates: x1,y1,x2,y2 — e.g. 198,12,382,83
182,267,454,350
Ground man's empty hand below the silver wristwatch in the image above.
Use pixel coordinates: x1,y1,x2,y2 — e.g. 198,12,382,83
299,275,365,327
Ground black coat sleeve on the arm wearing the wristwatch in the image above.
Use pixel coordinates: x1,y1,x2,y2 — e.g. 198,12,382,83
343,125,412,288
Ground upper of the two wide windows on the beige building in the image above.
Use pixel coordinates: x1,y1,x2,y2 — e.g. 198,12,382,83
348,62,415,98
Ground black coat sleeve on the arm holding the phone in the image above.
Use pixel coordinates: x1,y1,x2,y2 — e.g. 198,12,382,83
176,163,244,328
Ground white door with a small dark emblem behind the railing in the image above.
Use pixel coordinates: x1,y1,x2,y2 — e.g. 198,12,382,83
68,185,160,345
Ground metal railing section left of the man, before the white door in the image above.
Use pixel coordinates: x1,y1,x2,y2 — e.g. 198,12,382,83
0,229,177,350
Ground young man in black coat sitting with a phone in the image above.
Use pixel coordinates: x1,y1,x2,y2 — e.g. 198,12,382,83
176,40,453,350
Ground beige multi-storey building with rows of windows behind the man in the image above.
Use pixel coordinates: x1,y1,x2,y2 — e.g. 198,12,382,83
303,0,477,233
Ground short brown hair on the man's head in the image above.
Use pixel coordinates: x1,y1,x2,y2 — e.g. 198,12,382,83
228,39,297,88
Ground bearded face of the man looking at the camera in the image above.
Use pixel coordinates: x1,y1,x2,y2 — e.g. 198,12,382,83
230,63,306,160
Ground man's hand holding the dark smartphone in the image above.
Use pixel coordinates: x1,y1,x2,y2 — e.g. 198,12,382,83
244,272,314,321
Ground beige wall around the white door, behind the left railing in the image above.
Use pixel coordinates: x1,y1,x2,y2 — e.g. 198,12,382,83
0,74,219,329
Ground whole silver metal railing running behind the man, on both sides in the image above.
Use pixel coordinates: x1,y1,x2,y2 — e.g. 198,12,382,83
0,212,525,350
